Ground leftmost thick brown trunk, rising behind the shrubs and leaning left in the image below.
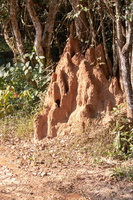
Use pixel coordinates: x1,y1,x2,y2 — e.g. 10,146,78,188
9,0,25,62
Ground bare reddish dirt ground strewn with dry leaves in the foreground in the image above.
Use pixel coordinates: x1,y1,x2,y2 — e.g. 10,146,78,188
0,135,133,200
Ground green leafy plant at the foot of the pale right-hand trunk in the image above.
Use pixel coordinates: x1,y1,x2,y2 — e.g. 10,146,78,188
112,105,133,159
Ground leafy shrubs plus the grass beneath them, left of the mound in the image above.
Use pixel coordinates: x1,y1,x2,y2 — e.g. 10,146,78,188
0,51,52,140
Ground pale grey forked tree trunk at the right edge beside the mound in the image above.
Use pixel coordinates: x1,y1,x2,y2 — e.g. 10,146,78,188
115,0,133,119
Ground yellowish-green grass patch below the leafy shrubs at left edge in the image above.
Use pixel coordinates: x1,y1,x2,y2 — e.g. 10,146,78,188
0,111,33,141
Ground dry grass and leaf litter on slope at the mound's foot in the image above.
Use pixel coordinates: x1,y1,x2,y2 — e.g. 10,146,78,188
31,120,114,167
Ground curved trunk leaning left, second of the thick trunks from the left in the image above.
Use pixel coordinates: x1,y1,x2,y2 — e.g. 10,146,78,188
26,0,44,56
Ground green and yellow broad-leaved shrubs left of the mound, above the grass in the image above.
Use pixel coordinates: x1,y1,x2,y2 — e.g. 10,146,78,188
0,52,52,117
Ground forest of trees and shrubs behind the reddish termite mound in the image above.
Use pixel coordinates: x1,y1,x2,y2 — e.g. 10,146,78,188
0,0,133,118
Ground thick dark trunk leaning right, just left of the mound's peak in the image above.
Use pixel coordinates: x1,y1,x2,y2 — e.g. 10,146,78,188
42,0,62,66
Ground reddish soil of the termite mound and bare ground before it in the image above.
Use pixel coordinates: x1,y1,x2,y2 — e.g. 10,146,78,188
0,32,133,200
